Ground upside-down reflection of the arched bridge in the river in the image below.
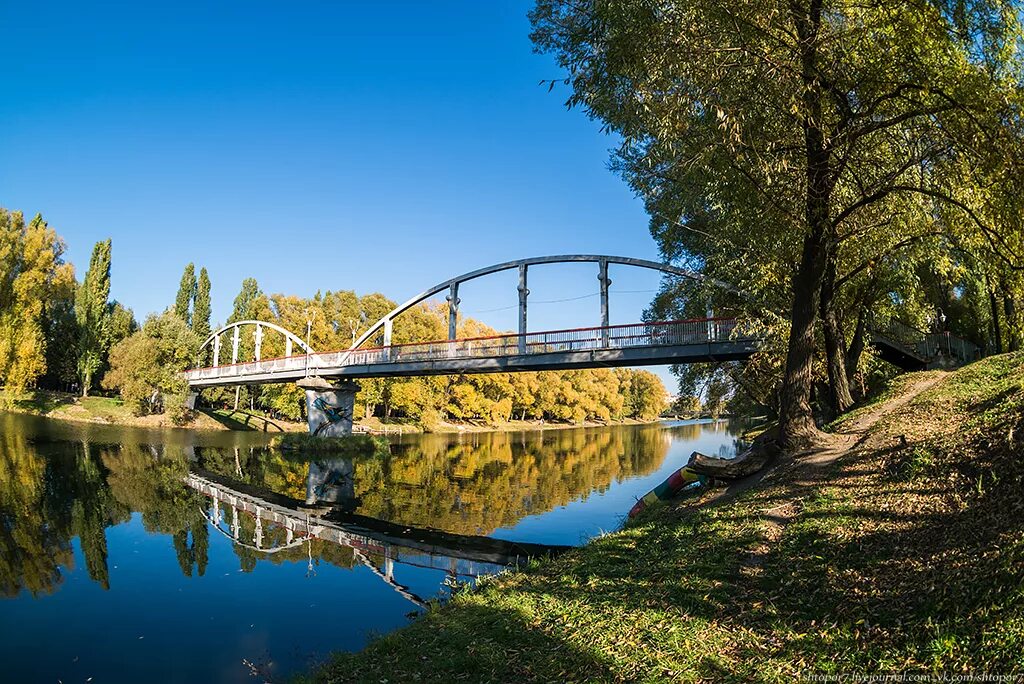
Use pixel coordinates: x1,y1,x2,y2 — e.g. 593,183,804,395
185,460,568,607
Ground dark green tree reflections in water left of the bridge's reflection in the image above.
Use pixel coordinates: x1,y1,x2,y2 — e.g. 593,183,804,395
0,425,222,596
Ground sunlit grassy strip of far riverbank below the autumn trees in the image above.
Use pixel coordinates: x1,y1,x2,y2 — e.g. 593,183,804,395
6,390,657,435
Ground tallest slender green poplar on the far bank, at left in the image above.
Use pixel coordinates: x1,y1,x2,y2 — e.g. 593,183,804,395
75,239,111,396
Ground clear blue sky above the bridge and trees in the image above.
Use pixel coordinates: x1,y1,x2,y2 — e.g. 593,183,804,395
0,1,679,389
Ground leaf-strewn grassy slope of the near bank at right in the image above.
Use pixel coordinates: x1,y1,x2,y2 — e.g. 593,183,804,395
312,354,1024,682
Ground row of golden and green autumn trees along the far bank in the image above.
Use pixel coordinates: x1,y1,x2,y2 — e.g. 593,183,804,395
0,209,667,428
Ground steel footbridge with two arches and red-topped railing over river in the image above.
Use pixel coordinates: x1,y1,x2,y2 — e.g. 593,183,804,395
185,254,760,389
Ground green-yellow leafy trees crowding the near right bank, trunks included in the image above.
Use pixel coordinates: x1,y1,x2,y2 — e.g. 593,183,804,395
530,0,1024,446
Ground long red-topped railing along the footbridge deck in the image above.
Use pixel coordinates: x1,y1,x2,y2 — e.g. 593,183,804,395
187,318,754,380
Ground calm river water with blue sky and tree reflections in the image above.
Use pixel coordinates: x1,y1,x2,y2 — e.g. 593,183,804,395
0,414,735,684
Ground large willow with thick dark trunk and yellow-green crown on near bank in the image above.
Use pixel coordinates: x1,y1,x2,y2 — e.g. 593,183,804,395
530,0,1020,446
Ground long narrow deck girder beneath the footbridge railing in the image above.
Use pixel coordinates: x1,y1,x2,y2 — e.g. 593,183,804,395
187,340,758,389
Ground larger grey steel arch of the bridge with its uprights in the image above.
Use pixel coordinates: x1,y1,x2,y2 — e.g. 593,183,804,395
349,254,743,351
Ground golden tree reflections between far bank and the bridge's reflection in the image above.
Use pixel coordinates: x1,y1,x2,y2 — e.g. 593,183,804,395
193,426,671,535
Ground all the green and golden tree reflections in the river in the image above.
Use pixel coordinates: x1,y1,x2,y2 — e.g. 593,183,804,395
0,425,737,596
